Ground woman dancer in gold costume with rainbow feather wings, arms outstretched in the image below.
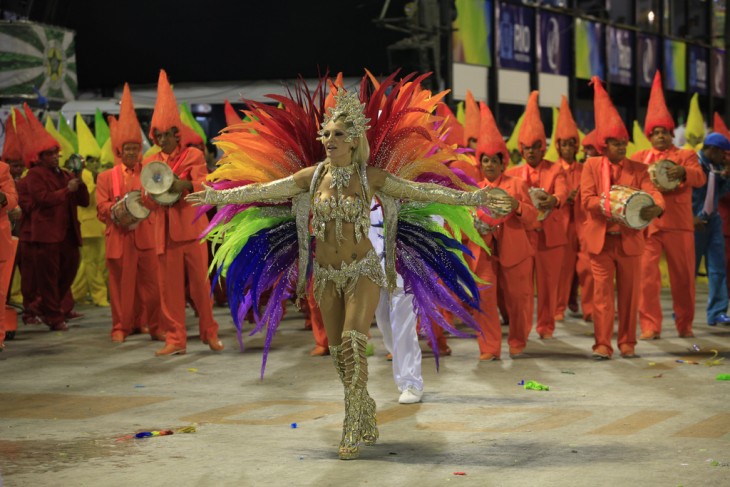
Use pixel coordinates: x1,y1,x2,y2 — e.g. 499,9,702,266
186,73,510,460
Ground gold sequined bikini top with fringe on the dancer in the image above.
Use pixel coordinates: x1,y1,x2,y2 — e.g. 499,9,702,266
312,163,370,244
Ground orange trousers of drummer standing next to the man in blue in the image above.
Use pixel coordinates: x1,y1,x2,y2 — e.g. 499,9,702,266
639,230,695,335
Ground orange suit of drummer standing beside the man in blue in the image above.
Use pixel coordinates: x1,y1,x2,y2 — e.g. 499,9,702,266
632,146,707,336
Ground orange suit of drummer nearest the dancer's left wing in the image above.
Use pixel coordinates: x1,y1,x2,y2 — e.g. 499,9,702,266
143,146,218,348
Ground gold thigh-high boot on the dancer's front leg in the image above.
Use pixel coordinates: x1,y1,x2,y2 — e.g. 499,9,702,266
339,330,377,460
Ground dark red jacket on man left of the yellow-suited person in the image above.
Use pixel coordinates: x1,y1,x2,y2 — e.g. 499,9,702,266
25,166,89,246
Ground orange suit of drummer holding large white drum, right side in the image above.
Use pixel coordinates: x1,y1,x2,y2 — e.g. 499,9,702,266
580,157,664,356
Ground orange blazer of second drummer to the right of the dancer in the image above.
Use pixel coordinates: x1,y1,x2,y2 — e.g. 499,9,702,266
505,160,570,247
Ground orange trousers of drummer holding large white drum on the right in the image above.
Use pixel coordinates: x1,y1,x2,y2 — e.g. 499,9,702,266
591,235,641,356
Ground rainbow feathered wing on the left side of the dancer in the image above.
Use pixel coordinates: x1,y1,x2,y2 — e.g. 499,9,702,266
201,78,327,377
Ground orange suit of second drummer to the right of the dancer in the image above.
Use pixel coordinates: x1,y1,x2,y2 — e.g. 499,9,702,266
506,160,569,338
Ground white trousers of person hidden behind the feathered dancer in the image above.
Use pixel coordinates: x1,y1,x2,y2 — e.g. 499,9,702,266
375,288,423,392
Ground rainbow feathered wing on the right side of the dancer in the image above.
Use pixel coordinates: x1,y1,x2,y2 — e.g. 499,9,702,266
360,73,486,367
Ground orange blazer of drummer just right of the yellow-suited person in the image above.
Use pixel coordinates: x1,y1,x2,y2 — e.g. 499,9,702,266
96,164,157,259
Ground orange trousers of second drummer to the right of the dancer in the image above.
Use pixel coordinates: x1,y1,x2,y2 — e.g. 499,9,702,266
532,232,566,336
